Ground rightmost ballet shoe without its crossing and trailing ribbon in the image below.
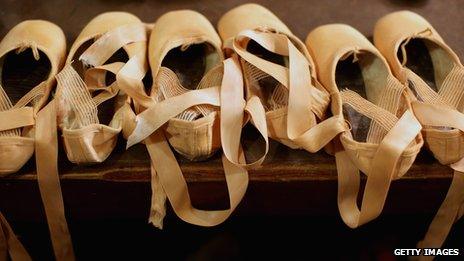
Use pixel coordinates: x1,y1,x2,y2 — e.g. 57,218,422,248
374,11,464,165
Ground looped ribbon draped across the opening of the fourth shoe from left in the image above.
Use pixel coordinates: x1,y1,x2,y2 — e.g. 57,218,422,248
232,30,340,152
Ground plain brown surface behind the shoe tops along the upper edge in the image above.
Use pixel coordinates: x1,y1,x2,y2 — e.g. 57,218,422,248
0,0,464,57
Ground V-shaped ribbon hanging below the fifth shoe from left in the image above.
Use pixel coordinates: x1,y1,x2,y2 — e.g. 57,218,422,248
335,111,421,228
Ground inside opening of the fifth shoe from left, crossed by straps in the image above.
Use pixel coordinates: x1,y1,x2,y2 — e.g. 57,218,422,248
335,53,402,143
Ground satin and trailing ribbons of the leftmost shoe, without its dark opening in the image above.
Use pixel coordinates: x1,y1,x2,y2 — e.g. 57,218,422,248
0,20,74,260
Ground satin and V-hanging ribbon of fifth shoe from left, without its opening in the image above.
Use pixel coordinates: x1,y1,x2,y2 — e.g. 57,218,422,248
306,24,423,228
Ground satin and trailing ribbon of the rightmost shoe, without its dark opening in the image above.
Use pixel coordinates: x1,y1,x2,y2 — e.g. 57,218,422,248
374,11,464,260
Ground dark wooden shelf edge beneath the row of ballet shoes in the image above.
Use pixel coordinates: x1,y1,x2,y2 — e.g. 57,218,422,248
0,126,452,221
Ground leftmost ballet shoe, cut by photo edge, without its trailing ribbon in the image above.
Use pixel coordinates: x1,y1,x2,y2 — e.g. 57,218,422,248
0,20,66,176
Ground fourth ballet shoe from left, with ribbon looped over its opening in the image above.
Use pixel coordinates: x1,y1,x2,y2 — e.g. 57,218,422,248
218,4,346,162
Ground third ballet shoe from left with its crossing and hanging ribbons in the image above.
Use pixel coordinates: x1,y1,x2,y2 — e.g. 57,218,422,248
128,10,248,228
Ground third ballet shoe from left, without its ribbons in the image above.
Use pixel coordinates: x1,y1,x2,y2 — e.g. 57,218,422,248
128,11,223,160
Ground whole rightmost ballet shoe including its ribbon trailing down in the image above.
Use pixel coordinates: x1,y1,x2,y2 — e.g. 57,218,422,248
374,11,464,259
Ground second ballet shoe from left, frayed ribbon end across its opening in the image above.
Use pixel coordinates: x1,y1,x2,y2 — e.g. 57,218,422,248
56,12,148,164
